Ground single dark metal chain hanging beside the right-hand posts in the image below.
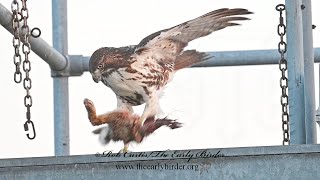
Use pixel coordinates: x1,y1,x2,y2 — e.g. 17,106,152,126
276,4,290,145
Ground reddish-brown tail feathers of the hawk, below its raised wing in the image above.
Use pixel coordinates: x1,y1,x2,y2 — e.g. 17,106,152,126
174,50,213,71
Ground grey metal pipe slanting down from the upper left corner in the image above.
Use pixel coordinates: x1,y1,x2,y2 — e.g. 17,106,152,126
0,3,68,71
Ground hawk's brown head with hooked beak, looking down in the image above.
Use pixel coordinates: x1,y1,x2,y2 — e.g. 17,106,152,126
89,46,134,83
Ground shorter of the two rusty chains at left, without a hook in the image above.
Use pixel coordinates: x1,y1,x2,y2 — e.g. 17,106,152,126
11,0,22,83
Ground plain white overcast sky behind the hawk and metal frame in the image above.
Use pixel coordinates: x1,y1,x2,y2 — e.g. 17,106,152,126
0,0,320,158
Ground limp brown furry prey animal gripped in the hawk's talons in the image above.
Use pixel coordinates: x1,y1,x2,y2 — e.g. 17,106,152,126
83,99,181,152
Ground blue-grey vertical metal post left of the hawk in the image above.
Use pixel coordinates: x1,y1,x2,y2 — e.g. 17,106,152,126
52,0,70,156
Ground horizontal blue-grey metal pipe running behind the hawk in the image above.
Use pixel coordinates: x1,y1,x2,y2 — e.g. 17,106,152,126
76,48,320,71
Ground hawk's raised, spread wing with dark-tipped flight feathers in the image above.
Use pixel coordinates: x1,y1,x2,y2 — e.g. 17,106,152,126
136,8,252,61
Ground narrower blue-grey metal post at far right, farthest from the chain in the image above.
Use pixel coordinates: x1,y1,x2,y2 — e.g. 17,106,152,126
302,0,317,144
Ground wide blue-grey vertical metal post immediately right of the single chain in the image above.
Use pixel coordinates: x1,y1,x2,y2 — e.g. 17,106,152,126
285,0,306,144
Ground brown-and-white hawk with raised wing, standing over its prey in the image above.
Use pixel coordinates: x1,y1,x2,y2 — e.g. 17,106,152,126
89,8,251,124
